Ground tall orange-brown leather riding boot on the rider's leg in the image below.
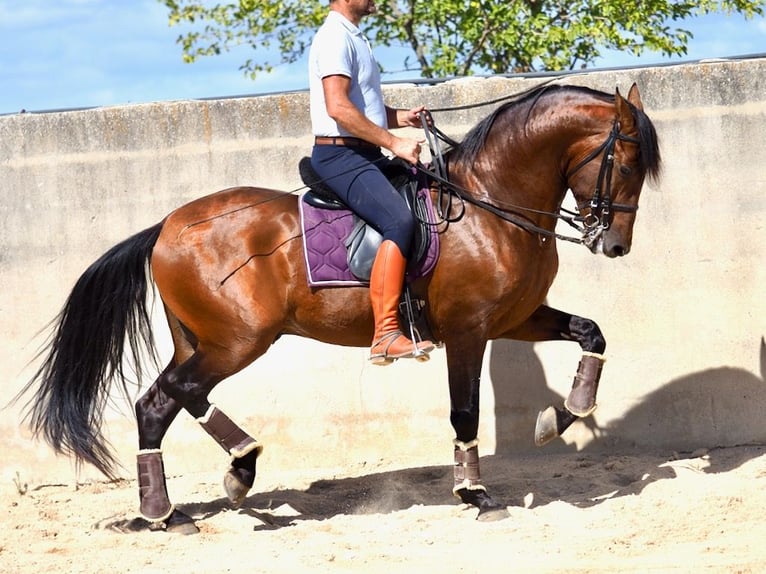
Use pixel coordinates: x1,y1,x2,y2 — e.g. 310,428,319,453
370,240,434,365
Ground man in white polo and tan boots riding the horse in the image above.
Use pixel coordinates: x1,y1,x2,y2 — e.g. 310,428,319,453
309,0,434,364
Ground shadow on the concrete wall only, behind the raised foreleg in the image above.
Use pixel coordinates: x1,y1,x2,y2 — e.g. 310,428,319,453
489,338,766,462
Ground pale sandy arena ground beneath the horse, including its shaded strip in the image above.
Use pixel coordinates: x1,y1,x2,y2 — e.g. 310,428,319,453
0,446,766,574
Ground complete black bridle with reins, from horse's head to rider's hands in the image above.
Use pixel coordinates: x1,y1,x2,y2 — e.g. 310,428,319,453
418,110,641,249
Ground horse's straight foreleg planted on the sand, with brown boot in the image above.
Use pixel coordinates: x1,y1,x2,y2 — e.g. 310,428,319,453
447,341,508,521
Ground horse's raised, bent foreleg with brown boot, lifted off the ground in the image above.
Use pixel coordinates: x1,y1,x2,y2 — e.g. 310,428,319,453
509,305,606,446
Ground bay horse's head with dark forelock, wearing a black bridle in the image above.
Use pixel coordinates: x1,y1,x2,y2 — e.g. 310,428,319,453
567,84,660,257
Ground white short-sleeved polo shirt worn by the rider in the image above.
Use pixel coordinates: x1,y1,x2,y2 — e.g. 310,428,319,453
309,10,388,136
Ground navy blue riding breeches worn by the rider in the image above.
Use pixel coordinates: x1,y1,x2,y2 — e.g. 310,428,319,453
311,145,415,257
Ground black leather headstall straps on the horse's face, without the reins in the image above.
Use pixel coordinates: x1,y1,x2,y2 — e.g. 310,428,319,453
567,120,641,248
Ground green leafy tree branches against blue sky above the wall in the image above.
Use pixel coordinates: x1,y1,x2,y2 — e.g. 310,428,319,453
158,0,766,78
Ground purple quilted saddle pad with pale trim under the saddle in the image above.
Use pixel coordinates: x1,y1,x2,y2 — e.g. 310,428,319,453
298,188,439,287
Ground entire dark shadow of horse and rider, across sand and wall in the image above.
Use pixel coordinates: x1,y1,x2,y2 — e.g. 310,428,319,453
103,339,766,532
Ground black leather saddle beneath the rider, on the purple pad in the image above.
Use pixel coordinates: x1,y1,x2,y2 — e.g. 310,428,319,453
298,157,431,281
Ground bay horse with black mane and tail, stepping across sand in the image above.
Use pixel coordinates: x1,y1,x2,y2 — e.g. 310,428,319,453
22,84,661,532
